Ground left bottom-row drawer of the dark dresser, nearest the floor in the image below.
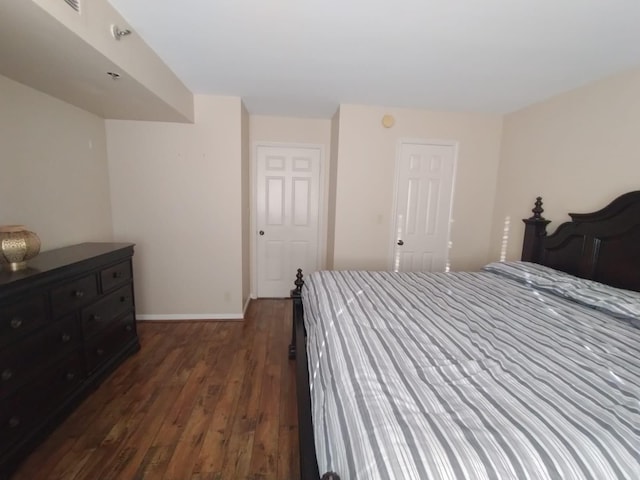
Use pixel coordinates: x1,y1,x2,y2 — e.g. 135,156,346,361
0,352,84,445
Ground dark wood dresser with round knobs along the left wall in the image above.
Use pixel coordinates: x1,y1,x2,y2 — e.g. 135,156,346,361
0,243,140,479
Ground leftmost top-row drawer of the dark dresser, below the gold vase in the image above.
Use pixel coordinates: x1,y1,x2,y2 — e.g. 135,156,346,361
0,295,47,348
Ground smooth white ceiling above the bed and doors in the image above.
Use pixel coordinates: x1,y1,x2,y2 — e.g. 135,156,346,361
109,0,640,118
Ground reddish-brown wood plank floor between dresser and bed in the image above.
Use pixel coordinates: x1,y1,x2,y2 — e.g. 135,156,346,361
12,299,299,480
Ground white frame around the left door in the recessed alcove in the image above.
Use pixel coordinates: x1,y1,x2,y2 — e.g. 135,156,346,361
249,141,327,299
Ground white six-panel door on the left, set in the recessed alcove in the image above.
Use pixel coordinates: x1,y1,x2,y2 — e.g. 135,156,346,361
256,146,320,297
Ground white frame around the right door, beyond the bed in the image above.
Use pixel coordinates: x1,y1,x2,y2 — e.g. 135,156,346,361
388,138,459,272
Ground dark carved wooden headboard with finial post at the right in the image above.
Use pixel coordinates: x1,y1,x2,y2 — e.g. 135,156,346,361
522,191,640,291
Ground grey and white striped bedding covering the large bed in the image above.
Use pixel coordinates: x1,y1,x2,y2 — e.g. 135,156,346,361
302,271,640,480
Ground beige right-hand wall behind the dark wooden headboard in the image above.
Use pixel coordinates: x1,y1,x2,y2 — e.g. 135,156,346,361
491,69,640,259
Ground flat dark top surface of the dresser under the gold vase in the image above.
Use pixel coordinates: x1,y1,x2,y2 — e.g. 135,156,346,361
0,242,134,287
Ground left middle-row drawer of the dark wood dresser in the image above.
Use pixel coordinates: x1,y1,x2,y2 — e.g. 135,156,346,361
0,317,80,398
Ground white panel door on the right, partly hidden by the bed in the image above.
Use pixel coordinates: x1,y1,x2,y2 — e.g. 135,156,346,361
393,143,456,272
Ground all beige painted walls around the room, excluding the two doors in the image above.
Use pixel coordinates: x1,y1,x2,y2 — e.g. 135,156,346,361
8,49,640,318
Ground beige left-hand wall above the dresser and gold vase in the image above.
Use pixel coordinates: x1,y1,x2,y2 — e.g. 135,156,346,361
0,76,113,251
